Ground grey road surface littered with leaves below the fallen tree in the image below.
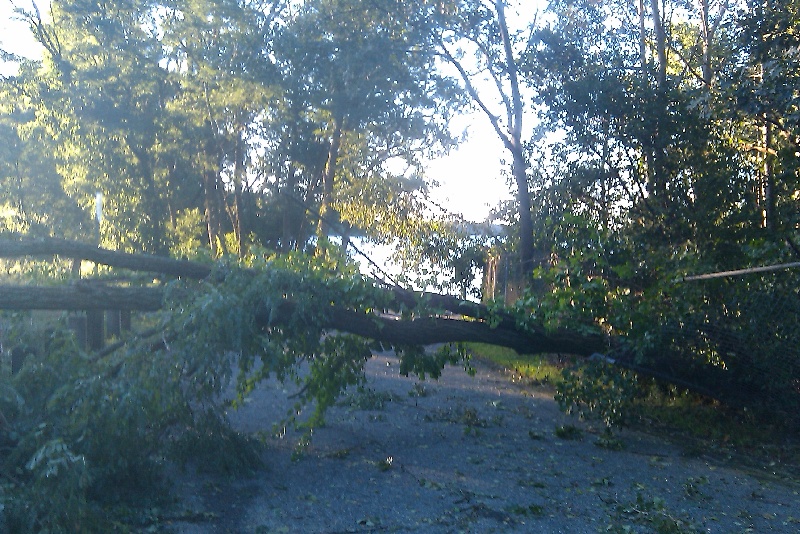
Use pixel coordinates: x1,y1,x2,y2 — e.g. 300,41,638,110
170,354,800,534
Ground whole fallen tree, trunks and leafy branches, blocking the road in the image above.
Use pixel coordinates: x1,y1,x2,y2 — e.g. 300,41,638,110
0,241,792,531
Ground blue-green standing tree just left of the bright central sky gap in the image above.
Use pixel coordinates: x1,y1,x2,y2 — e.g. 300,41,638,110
275,0,450,255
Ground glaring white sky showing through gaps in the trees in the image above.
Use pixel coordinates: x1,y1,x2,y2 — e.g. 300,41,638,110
0,0,511,222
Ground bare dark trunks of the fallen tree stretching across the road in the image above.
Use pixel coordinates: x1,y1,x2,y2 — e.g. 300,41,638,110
0,235,768,406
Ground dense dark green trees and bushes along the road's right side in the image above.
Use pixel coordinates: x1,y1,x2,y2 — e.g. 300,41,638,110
521,0,798,428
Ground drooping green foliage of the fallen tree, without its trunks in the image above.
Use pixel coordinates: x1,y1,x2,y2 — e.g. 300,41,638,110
0,251,478,532
